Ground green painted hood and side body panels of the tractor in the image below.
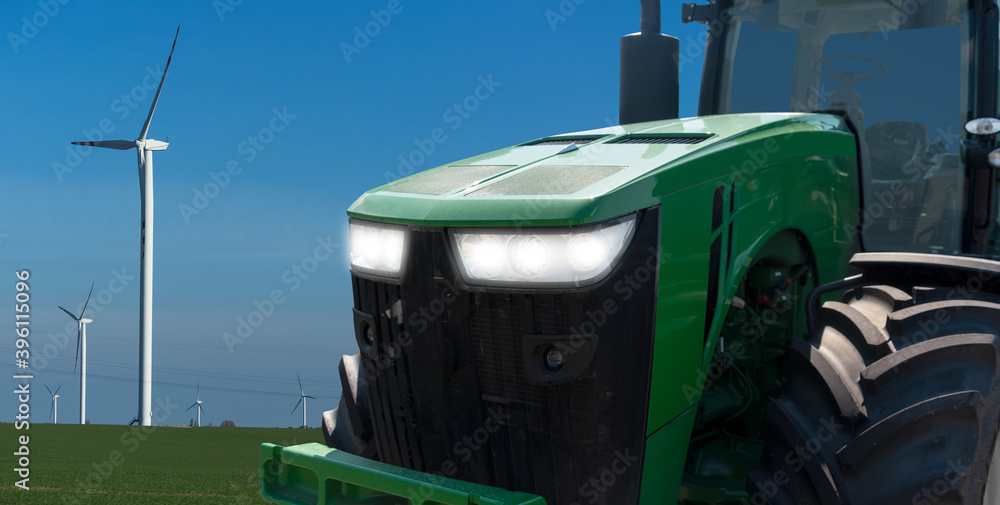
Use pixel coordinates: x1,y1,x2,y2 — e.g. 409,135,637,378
264,114,860,505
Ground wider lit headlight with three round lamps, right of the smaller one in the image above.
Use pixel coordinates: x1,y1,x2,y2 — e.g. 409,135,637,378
451,215,635,286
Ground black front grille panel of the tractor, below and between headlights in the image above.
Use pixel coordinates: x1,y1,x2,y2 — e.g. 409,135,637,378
353,209,659,505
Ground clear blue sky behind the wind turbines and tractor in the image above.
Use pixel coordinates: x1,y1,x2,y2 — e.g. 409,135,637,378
0,0,704,426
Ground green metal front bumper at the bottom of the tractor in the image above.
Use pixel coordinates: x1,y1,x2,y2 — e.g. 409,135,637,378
260,444,545,505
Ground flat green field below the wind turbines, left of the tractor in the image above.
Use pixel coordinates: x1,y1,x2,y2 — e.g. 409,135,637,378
0,424,323,505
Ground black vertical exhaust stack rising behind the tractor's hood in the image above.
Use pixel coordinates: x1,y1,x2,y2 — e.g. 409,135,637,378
618,0,680,124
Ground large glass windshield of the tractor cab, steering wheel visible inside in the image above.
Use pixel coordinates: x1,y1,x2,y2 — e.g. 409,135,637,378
716,0,972,254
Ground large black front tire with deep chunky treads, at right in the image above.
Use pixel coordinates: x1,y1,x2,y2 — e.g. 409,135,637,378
747,286,1000,505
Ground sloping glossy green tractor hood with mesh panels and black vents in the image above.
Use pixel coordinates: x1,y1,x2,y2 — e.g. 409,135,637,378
348,114,856,226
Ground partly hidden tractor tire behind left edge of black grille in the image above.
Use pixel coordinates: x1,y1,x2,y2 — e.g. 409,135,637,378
323,354,378,460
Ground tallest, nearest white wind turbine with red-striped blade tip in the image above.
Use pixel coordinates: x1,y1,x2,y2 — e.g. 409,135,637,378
73,26,181,426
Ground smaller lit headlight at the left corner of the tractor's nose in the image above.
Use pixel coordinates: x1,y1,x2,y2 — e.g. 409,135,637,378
350,221,406,278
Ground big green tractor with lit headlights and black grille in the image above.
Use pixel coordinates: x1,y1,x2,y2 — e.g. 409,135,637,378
261,0,1000,505
